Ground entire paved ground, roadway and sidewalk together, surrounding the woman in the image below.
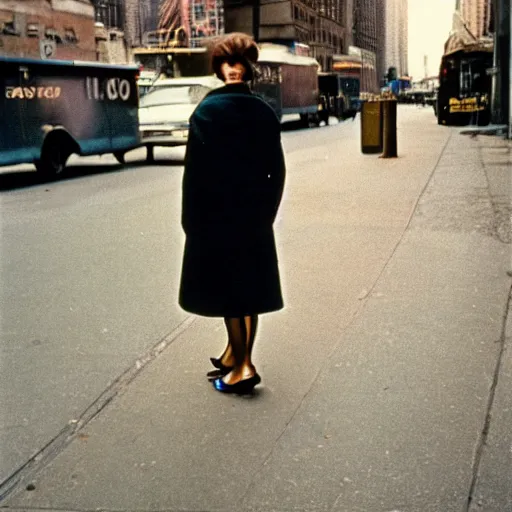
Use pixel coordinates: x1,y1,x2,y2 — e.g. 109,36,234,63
0,106,512,512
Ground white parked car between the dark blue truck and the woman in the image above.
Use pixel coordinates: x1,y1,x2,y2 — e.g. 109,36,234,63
135,76,224,160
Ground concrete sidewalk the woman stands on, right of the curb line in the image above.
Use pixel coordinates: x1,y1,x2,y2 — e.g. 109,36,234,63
1,106,512,512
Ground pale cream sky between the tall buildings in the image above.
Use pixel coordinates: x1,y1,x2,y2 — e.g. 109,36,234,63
408,0,455,80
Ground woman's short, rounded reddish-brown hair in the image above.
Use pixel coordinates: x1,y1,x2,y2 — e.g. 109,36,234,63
212,32,259,82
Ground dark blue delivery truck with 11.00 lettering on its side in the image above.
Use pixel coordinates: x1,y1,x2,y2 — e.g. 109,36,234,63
0,56,140,177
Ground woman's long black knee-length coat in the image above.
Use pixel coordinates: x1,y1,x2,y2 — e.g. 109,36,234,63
179,84,285,317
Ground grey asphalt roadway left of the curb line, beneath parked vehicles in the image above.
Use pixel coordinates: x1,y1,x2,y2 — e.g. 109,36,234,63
0,114,352,482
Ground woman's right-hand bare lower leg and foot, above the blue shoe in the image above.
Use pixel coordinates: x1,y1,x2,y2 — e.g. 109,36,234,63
222,315,258,384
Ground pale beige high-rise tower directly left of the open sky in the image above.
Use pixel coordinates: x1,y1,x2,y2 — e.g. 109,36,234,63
384,0,408,76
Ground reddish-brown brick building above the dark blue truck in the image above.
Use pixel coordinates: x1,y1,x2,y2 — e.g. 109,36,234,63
0,0,97,61
